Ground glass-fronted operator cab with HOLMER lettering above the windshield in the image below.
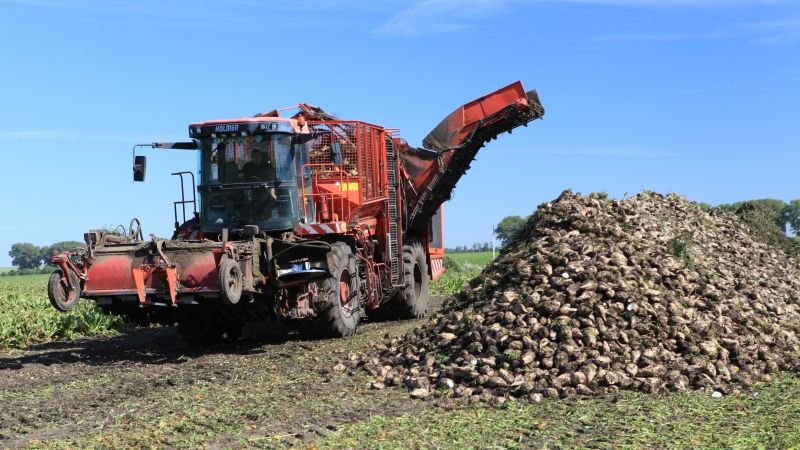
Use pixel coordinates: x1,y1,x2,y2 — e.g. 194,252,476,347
189,118,313,234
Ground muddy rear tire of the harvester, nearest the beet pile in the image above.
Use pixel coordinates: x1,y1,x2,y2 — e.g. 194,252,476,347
369,241,428,322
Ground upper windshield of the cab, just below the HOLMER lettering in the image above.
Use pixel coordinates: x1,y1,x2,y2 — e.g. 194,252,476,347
200,133,294,185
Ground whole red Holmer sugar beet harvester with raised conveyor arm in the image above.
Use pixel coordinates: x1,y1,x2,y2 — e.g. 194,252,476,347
48,82,544,344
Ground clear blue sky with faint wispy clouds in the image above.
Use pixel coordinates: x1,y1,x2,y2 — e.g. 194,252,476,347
0,0,800,266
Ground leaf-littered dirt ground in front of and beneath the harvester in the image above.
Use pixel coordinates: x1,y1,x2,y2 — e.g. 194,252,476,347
0,297,450,448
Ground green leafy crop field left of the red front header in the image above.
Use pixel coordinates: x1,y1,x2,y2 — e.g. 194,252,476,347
0,275,122,350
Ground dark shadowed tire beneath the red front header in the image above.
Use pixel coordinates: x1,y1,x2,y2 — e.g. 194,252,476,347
178,309,244,347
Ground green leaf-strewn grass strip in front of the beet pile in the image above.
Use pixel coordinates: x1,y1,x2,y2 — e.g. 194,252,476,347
320,374,800,449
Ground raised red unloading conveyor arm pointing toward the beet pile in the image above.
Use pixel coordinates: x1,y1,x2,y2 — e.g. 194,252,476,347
400,81,544,235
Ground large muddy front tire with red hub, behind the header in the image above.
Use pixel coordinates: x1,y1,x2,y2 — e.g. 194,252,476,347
304,242,361,338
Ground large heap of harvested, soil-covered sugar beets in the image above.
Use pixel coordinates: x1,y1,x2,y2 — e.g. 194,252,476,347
340,191,800,402
